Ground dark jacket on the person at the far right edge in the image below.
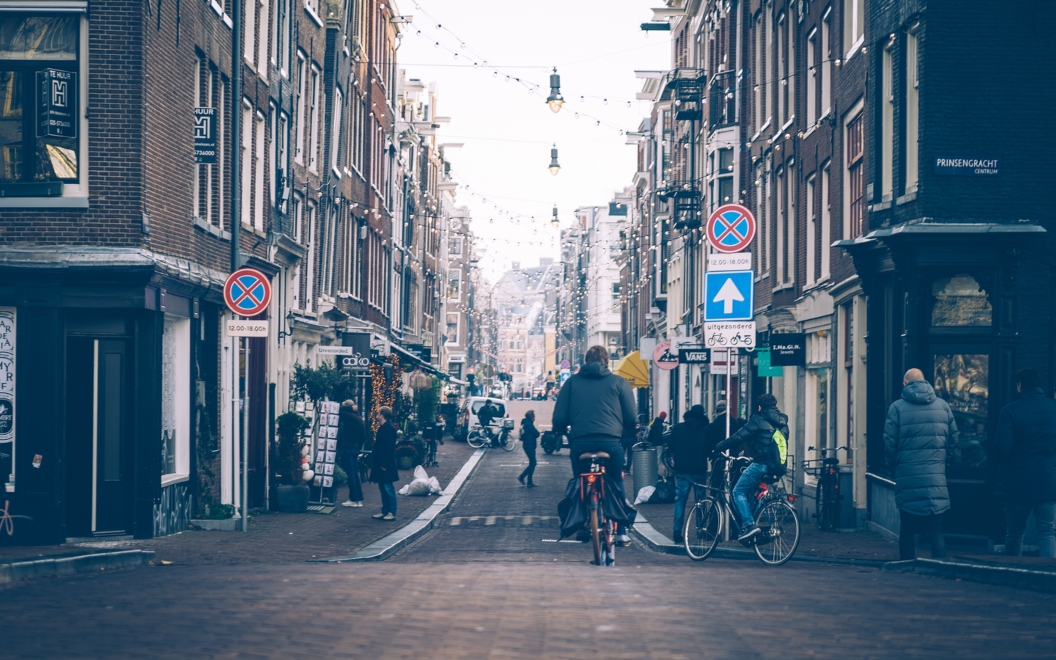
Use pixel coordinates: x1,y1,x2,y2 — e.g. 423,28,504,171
995,388,1056,502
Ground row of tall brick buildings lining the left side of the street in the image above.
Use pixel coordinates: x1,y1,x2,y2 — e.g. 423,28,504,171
0,0,470,542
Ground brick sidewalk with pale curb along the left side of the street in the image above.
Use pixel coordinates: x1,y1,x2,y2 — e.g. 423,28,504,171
0,439,474,564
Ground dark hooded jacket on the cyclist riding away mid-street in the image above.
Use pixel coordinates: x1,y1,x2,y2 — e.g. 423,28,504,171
553,362,638,444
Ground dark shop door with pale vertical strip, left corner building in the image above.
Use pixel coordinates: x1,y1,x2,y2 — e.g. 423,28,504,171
65,338,132,536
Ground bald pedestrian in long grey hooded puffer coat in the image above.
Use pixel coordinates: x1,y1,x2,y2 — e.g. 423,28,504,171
884,369,958,561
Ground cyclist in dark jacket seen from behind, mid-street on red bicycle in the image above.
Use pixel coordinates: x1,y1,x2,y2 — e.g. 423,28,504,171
553,346,638,545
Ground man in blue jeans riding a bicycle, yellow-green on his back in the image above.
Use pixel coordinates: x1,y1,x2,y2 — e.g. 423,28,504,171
715,394,789,542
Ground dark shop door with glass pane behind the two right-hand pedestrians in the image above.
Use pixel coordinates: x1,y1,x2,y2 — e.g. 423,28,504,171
931,344,998,536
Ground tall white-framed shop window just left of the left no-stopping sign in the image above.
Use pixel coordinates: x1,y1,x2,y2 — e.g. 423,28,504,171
162,314,191,486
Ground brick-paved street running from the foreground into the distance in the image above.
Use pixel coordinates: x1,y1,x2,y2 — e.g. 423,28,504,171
6,407,1056,658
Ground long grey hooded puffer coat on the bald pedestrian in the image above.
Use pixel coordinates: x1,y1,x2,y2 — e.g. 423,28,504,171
884,380,958,515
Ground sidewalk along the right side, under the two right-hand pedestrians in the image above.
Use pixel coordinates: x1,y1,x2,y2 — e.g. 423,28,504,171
624,468,1056,592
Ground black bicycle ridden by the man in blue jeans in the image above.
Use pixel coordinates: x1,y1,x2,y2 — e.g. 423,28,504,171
682,453,799,566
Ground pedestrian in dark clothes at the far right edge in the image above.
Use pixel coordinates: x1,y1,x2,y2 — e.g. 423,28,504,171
994,369,1056,558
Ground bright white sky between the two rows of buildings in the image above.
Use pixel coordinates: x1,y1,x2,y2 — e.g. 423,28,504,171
397,0,670,282
